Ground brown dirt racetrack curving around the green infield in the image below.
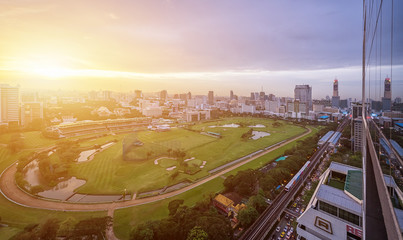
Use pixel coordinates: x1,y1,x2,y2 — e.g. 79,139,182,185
0,126,312,211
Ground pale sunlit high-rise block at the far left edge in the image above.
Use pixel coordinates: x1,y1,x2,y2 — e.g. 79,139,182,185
0,84,20,124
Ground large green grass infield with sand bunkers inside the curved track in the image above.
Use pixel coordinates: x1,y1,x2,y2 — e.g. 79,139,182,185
71,118,306,194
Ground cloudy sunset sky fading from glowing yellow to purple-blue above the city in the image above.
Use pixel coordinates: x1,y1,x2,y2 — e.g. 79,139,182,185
0,0,403,99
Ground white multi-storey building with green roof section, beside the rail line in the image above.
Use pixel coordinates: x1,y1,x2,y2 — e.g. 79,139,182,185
297,162,403,240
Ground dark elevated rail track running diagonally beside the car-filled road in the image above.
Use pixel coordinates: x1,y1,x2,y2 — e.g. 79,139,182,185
240,118,349,240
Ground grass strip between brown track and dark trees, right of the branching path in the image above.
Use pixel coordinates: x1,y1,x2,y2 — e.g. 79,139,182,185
113,178,224,239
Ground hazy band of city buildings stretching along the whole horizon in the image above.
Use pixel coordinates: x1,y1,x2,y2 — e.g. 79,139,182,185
0,78,403,137
